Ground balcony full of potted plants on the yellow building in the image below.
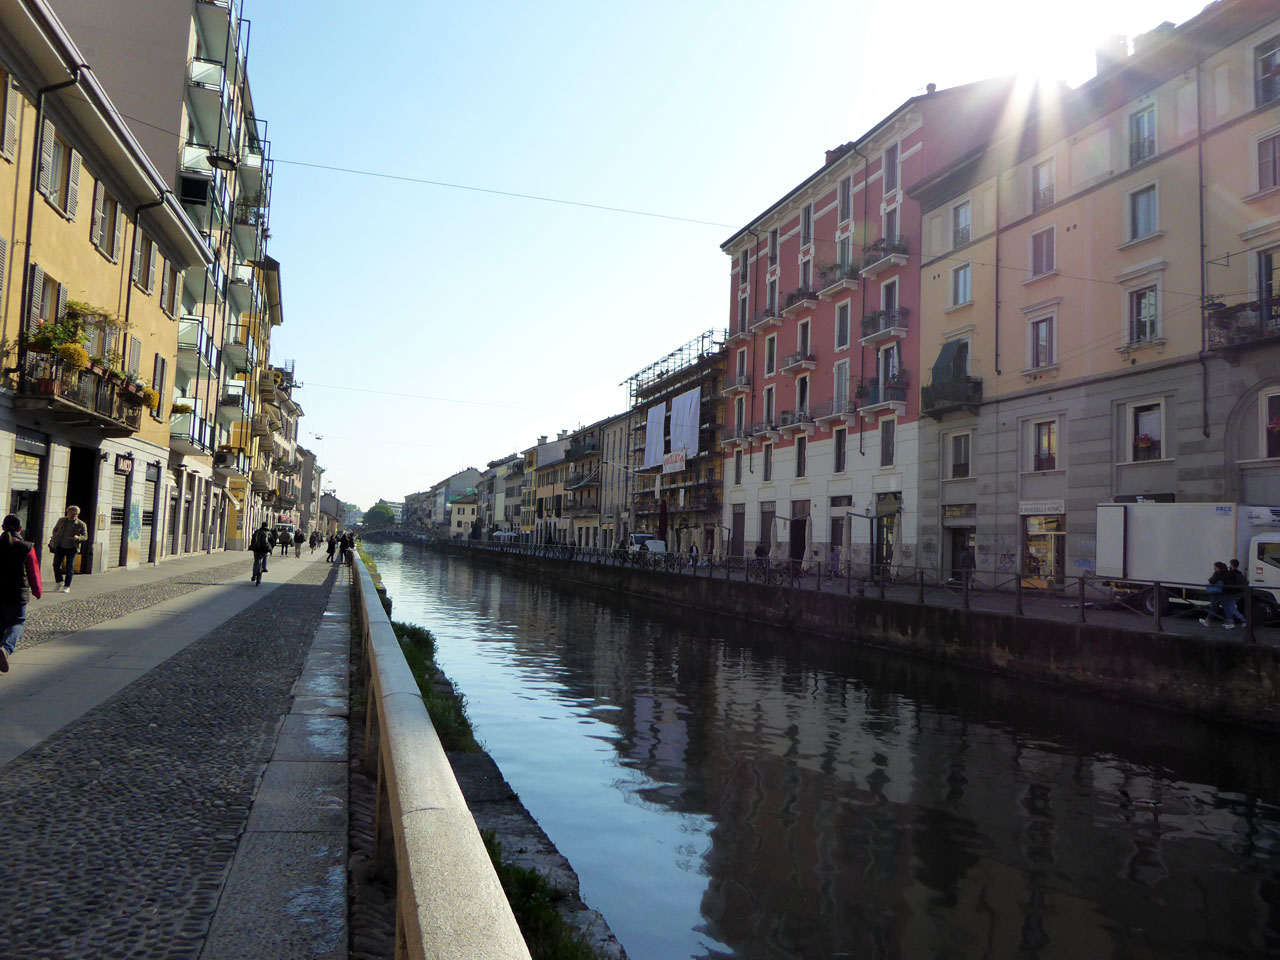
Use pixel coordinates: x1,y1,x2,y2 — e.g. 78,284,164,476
15,351,142,436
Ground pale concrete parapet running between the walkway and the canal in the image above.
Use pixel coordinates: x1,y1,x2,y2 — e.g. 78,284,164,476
353,563,529,960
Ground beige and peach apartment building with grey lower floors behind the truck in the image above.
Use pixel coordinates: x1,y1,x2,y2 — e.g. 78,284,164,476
913,0,1280,582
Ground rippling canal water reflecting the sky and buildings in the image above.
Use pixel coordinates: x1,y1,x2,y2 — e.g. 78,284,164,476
367,544,1280,960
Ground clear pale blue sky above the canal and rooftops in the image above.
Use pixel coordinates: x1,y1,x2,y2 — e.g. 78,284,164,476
244,0,1203,508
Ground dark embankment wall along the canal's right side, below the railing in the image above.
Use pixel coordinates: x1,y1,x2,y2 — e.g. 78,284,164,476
438,544,1280,730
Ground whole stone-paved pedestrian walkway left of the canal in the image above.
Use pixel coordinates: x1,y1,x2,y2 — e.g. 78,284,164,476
0,552,351,960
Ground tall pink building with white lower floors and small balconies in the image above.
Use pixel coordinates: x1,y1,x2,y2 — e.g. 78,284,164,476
721,79,1011,567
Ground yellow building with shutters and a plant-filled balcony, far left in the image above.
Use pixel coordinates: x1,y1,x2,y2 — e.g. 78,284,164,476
0,4,212,571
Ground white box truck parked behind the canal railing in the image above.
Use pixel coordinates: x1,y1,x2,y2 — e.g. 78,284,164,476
1094,503,1280,623
